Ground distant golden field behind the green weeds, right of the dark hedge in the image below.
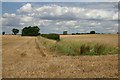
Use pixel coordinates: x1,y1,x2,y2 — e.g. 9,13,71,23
60,34,118,46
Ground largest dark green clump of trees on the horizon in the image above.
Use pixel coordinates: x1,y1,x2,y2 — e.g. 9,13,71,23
22,26,40,36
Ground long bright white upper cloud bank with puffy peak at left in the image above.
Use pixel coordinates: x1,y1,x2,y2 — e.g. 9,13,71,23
18,3,117,20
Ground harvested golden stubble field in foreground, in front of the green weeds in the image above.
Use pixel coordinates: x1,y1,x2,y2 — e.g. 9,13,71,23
2,36,118,78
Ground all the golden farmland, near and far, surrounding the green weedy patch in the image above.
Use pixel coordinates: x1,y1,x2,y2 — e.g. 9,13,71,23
2,34,118,78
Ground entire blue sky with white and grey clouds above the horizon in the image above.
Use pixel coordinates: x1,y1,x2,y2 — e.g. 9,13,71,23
2,0,118,33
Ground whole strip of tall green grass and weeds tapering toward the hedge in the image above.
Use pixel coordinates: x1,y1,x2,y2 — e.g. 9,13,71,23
39,37,118,56
